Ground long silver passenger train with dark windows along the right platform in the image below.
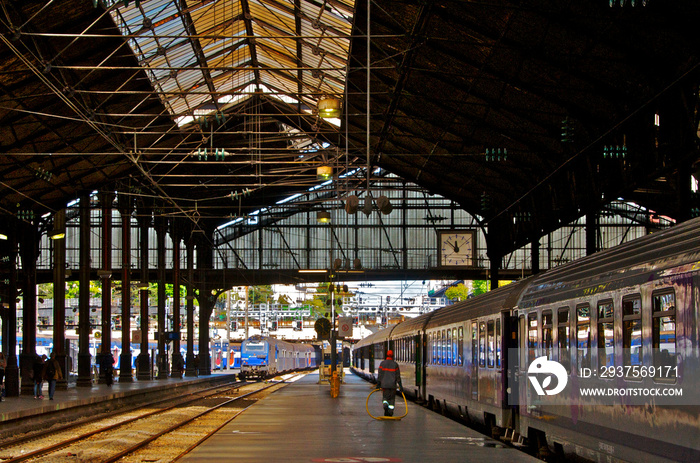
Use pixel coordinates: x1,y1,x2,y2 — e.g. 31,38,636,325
353,219,700,462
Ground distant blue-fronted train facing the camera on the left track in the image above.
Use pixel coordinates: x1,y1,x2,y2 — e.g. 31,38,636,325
239,336,318,379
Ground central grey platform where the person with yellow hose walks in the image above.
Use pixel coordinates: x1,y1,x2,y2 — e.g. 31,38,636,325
179,373,540,463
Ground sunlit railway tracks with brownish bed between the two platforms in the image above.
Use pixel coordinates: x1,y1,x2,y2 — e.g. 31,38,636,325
0,375,302,463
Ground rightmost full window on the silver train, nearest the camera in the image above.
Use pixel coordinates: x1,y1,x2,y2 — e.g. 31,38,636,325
651,293,676,381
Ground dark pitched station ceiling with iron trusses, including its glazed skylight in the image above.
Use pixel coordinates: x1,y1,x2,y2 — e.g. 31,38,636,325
0,0,700,258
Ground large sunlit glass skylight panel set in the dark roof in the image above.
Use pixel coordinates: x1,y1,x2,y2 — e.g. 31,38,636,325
110,0,355,123
